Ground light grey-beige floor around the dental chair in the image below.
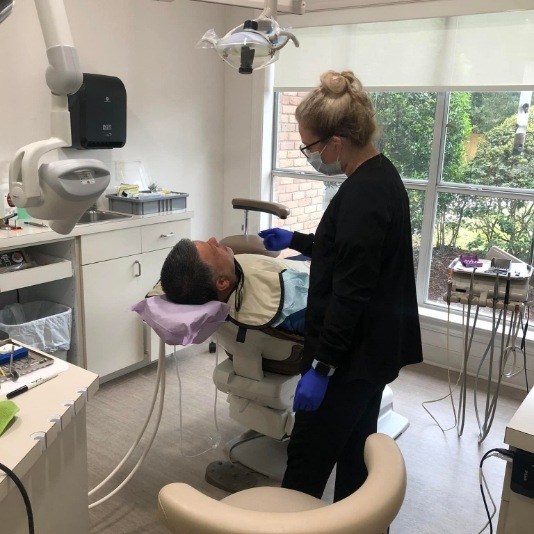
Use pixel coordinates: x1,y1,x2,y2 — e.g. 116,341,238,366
87,344,526,534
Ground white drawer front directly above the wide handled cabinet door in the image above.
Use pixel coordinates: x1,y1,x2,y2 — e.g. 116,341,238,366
80,227,141,265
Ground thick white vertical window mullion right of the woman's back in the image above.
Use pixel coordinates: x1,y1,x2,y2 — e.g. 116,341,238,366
416,93,449,304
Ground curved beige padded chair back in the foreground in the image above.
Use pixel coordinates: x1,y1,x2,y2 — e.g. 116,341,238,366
158,434,406,534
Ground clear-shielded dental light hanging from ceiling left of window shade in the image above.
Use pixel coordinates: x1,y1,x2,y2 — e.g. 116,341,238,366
197,0,299,74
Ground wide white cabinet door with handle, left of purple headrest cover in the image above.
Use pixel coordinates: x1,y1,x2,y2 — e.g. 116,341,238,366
82,254,149,377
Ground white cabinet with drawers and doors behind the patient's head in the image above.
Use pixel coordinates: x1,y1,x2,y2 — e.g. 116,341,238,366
80,220,190,381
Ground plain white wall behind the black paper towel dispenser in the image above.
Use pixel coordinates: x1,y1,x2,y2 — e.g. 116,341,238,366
0,0,233,238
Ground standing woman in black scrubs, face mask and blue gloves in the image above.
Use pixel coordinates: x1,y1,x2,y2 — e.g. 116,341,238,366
260,71,422,501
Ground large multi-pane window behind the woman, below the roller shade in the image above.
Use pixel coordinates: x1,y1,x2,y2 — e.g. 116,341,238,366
272,91,534,306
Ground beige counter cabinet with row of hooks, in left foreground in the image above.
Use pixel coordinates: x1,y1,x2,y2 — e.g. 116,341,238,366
0,356,98,534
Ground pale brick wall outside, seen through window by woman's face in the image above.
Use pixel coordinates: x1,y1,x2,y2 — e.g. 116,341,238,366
273,93,325,233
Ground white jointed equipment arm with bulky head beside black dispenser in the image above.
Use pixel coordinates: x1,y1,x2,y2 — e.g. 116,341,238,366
4,0,110,234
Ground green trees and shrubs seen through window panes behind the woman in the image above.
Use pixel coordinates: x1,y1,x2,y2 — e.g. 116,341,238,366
358,92,534,258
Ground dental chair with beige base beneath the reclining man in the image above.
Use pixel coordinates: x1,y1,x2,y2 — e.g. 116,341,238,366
206,198,409,492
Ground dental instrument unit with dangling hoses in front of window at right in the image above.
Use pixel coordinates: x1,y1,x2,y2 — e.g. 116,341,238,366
423,247,532,443
